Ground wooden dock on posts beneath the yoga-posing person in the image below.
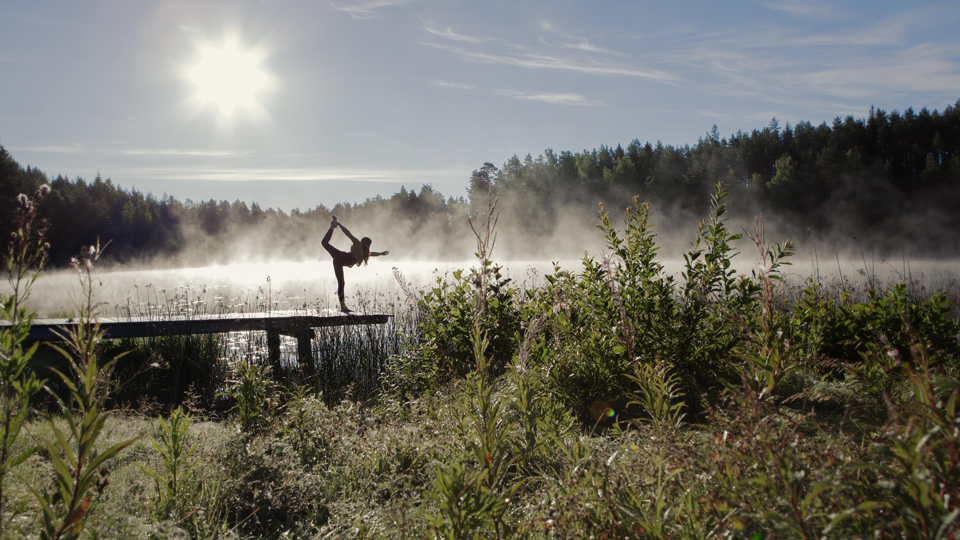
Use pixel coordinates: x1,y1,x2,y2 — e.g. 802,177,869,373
6,311,390,373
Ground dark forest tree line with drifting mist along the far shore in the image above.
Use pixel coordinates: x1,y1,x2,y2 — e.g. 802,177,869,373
0,100,960,266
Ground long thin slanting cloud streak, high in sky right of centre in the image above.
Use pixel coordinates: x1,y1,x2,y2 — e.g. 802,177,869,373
423,42,676,82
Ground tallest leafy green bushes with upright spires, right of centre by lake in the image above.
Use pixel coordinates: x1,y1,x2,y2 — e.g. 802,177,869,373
524,185,758,420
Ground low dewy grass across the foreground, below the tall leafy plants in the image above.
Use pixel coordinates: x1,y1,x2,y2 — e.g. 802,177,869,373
10,272,956,538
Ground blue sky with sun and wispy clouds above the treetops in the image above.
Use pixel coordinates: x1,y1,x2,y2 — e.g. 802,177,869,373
0,0,960,212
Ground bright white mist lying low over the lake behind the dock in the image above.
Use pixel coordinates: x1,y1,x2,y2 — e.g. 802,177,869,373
11,252,960,317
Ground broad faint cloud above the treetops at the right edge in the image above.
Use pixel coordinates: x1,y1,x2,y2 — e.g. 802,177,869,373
665,6,960,104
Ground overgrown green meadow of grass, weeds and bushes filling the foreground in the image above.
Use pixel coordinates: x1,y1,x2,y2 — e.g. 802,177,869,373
0,185,960,539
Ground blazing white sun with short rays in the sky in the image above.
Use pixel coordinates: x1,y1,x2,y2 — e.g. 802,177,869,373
186,39,270,116
